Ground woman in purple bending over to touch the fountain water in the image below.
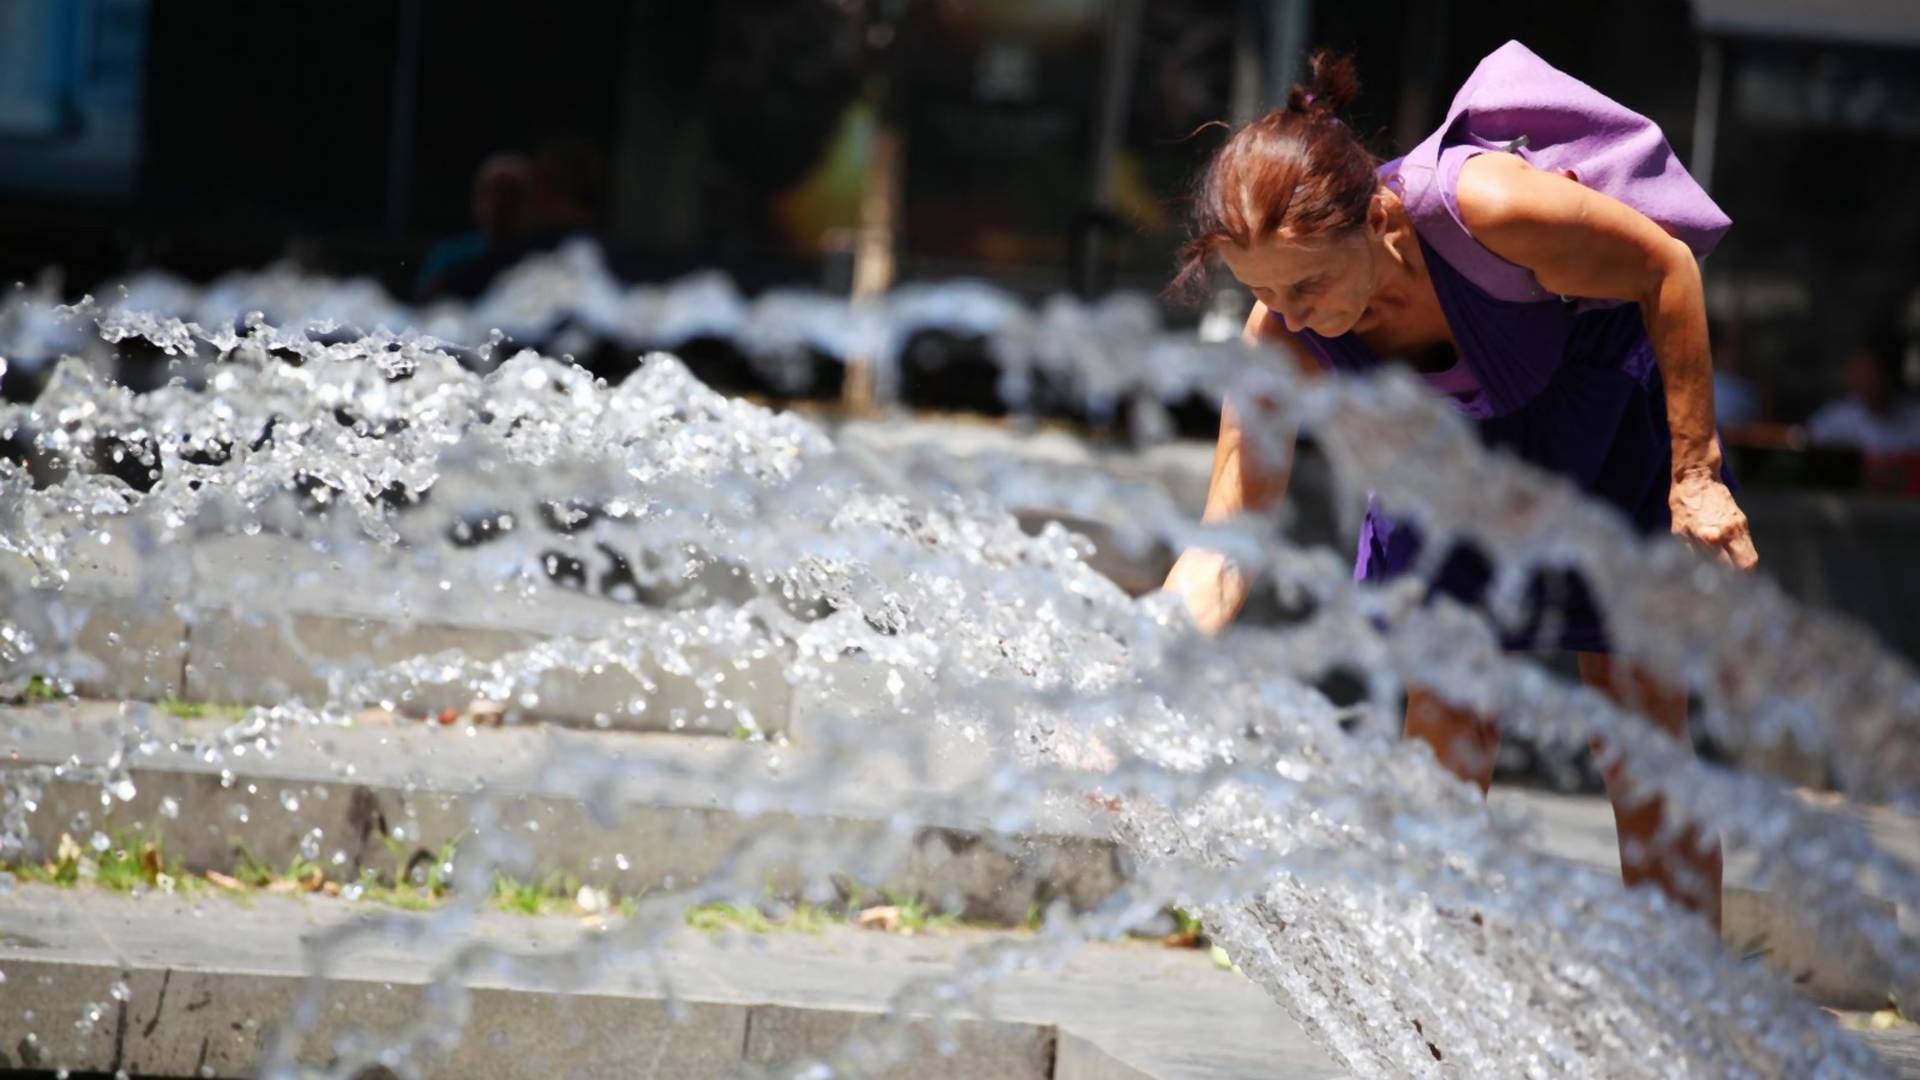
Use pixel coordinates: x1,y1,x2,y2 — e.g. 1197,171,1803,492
1167,42,1757,926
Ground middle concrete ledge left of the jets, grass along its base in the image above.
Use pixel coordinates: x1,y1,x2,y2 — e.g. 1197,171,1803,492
0,705,1127,924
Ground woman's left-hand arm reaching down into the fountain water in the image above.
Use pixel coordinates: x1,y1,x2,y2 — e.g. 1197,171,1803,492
1162,304,1317,634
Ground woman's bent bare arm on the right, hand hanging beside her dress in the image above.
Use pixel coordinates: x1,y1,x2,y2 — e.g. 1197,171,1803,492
1457,154,1759,571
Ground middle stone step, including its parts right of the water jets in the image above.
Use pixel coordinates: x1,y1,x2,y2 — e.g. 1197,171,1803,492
0,703,1912,1009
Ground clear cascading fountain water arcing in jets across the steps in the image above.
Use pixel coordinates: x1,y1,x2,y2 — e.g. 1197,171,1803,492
0,252,1920,1076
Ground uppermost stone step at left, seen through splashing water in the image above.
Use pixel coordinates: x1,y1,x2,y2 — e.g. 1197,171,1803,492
0,521,793,736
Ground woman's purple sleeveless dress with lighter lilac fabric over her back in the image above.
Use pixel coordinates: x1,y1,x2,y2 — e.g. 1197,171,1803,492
1296,42,1732,651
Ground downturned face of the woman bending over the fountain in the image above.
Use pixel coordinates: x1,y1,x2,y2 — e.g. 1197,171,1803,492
1219,221,1375,338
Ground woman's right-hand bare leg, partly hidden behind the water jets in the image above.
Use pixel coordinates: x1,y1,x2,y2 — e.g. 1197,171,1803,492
1580,653,1720,930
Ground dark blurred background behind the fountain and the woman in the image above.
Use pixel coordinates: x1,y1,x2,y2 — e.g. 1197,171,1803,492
0,0,1920,676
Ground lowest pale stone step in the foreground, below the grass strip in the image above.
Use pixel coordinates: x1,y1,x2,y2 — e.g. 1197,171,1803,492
0,886,1340,1080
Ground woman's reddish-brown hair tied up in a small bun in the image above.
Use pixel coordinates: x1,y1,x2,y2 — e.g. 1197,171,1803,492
1169,48,1379,294
